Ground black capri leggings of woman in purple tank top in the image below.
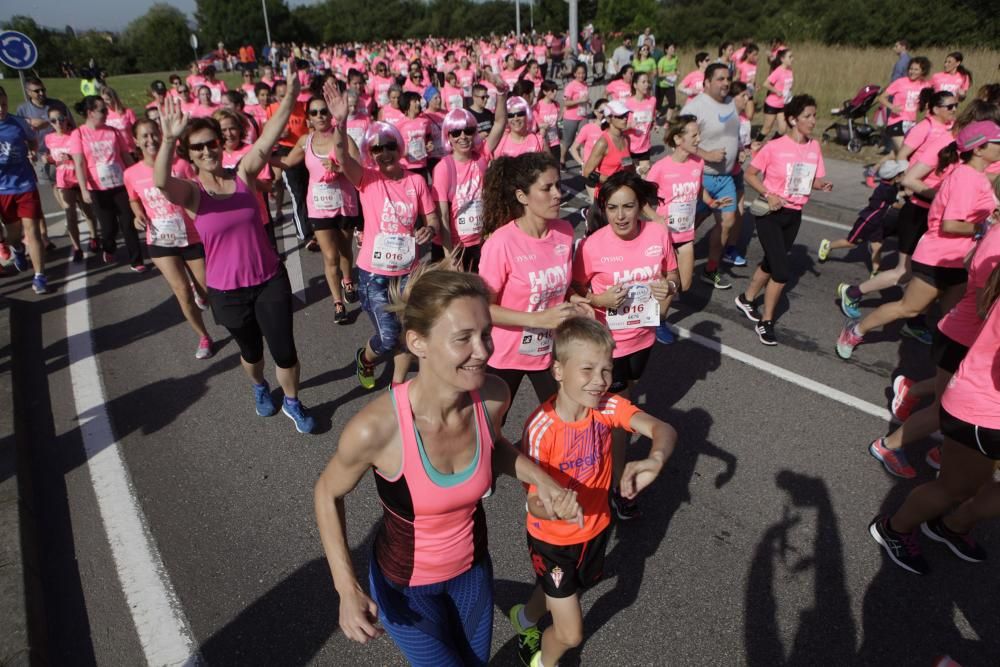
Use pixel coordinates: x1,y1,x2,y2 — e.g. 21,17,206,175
208,265,299,368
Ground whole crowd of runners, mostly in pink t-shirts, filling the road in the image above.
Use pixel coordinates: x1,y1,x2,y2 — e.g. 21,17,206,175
0,31,1000,667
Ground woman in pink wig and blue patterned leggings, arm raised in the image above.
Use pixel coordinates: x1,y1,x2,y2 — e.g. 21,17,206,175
323,81,451,389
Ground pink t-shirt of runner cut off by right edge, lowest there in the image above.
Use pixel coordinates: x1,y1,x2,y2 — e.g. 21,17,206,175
941,303,1000,429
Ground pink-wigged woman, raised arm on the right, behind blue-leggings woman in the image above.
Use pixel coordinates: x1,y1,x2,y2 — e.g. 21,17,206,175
432,82,507,272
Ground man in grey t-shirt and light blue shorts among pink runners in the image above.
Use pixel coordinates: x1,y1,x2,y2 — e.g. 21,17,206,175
681,63,747,289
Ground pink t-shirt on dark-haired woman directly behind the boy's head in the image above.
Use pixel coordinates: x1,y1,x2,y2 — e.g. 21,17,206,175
573,221,677,358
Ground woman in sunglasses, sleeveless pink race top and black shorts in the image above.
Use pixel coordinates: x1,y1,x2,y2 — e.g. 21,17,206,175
273,97,359,324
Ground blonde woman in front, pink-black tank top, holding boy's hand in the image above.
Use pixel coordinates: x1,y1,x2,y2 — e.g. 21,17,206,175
315,268,580,667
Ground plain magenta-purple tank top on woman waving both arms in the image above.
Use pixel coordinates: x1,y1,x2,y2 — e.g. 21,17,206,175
194,176,280,290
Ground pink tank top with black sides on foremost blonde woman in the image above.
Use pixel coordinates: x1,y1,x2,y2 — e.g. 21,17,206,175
375,382,493,586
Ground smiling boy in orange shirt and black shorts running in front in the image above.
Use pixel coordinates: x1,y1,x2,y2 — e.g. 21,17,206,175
510,317,677,667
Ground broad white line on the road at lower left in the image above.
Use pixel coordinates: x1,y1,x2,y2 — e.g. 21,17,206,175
64,269,202,665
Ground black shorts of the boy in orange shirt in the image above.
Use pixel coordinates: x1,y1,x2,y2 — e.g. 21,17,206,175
528,526,611,598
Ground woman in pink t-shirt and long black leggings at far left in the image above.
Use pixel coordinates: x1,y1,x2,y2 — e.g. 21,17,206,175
69,95,146,273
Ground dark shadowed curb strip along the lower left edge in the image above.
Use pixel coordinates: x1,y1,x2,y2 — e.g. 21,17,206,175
0,298,46,667
